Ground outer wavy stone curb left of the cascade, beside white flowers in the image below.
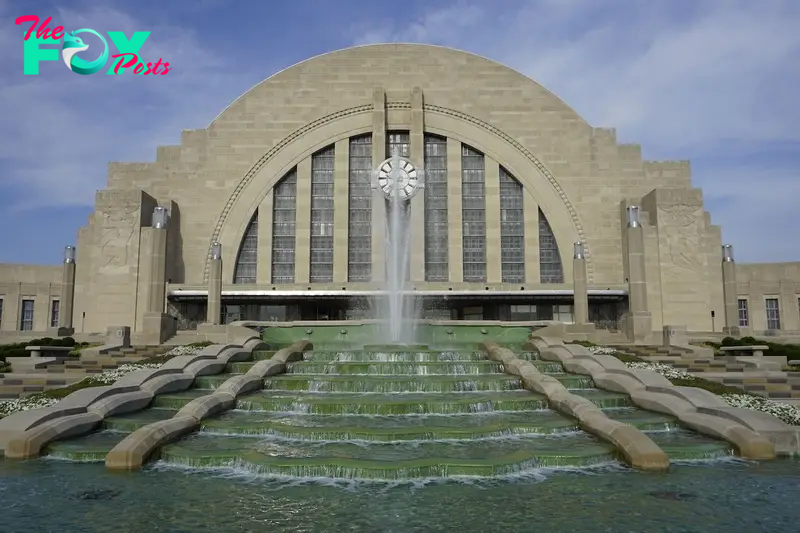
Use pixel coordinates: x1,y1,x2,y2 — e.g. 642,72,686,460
0,335,263,459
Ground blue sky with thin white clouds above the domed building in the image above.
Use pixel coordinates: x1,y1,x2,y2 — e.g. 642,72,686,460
0,0,800,264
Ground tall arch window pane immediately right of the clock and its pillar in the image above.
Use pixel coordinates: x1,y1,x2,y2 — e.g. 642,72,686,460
424,135,450,281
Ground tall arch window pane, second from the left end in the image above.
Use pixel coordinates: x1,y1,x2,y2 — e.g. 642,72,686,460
272,168,297,285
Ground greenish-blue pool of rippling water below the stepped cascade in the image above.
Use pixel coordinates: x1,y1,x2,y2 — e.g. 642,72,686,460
0,460,800,533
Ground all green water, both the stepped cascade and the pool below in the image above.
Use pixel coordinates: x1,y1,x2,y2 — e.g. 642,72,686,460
15,347,800,533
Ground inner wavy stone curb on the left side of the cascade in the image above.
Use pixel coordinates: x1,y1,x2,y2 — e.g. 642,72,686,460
106,340,312,471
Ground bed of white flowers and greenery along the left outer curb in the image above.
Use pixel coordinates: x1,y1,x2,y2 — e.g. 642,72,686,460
0,342,212,418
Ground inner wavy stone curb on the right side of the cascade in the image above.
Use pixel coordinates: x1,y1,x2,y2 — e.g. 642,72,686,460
482,342,669,471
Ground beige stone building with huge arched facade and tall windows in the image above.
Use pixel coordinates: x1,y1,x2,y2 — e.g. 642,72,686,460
0,44,800,337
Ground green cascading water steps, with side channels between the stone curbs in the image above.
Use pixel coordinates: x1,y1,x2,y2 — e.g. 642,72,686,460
42,346,732,480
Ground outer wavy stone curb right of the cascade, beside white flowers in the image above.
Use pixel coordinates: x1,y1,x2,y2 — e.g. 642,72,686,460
525,337,800,460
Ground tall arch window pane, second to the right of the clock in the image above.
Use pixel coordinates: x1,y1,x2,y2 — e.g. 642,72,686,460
461,141,486,283
